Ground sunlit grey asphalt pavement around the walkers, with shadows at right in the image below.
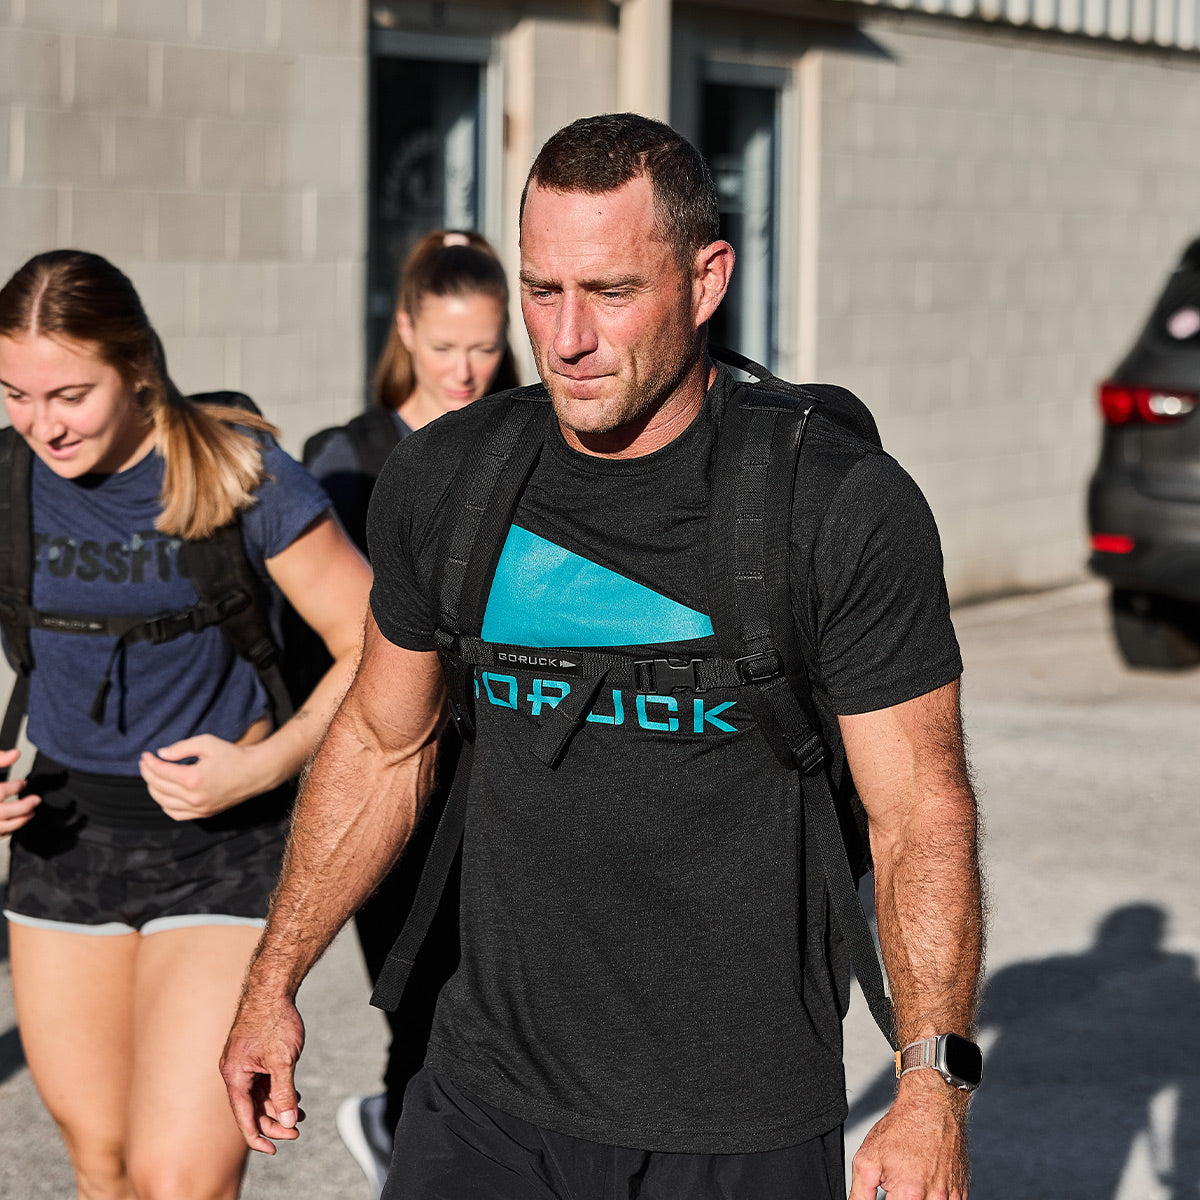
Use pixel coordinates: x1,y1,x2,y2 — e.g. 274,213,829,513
0,583,1200,1200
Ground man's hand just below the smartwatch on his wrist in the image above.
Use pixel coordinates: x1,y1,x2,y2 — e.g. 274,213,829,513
850,1070,970,1200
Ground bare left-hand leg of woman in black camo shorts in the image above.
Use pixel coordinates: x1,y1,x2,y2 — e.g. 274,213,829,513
8,922,142,1200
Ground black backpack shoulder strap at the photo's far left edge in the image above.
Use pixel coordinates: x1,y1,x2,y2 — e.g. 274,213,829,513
0,426,34,780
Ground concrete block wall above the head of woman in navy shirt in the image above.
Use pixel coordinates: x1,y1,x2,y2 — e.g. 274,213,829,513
0,0,367,450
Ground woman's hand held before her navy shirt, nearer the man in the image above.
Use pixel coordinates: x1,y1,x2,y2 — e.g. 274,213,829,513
138,733,275,821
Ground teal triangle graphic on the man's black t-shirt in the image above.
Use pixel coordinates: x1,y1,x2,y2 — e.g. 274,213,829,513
482,526,713,647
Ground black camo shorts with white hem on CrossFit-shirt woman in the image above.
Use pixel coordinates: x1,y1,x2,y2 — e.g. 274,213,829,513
4,758,290,934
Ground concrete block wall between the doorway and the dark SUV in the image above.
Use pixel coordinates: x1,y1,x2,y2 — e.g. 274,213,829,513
816,25,1200,609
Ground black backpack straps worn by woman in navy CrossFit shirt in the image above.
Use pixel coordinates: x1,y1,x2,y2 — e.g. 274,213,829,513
0,391,293,778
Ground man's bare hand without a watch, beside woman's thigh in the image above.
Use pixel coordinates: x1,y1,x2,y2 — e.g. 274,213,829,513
221,995,304,1154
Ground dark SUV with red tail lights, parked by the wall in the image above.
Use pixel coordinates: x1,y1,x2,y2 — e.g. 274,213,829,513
1087,239,1200,667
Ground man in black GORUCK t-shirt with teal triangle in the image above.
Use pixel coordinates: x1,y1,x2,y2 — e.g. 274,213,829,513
222,114,982,1200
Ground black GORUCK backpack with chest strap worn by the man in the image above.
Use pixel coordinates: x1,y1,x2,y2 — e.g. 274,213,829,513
372,347,899,1049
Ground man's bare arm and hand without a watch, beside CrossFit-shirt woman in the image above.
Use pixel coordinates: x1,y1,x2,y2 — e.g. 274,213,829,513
221,613,444,1154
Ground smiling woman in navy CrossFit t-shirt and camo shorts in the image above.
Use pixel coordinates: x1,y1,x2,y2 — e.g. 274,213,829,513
0,251,370,1200
